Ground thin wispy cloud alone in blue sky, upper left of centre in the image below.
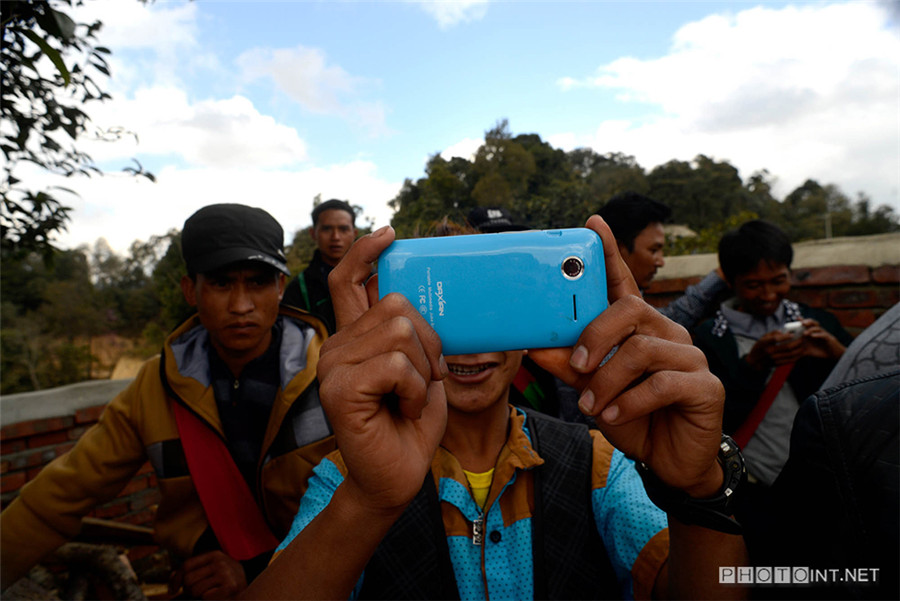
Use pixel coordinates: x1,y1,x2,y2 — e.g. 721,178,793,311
235,46,385,133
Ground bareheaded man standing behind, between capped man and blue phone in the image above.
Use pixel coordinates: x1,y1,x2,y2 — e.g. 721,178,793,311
282,198,356,334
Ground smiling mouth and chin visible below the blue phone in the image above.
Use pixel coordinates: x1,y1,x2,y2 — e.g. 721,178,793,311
444,351,525,413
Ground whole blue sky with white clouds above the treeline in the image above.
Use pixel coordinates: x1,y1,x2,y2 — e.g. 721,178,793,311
33,0,900,252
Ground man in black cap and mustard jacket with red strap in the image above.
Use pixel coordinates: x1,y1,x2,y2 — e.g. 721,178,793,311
0,204,334,599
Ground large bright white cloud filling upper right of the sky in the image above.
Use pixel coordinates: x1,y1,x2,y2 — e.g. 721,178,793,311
550,2,900,207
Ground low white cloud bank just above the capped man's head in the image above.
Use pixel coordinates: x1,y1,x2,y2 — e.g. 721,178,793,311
46,161,401,254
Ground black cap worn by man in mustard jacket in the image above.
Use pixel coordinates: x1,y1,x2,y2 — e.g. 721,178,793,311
181,204,291,275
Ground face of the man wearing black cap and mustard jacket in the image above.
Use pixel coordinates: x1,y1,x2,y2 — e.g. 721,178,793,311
181,263,284,362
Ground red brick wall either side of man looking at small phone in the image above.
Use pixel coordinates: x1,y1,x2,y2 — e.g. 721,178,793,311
644,265,900,336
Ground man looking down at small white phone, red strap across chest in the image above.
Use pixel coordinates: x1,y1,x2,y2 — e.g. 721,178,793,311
694,220,852,554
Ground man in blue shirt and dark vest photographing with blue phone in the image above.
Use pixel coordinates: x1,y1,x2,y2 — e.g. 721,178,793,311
245,216,746,599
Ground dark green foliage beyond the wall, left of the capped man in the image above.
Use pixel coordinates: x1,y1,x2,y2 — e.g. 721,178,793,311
0,230,192,394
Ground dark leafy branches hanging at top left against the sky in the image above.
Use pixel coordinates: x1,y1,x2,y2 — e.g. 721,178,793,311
0,0,153,262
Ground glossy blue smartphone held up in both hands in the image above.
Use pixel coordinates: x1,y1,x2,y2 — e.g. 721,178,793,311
378,228,609,355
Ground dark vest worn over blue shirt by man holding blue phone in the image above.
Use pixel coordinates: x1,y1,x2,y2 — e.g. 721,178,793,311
360,411,621,599
